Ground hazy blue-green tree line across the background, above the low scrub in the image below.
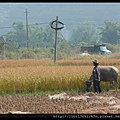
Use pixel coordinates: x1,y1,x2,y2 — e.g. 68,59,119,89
1,20,120,59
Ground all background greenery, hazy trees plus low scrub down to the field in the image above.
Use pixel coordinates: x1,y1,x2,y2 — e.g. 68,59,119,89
0,20,120,59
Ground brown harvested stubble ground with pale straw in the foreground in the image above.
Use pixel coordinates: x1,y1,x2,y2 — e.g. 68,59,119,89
0,91,120,114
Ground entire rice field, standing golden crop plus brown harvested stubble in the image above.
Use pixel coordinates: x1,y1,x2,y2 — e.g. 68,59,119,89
0,59,120,114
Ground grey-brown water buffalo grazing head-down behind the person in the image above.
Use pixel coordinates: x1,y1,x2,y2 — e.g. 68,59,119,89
86,66,119,92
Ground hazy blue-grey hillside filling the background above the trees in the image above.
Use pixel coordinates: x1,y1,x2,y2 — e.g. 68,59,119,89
0,2,120,38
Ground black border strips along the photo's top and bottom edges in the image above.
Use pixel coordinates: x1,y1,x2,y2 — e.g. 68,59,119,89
0,0,120,119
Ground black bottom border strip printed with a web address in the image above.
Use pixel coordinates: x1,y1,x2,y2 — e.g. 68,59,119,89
0,114,120,119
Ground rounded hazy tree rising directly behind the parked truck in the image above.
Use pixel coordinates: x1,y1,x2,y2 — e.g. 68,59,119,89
69,21,101,47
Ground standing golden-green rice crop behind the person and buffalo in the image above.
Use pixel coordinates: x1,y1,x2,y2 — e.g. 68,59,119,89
0,59,120,94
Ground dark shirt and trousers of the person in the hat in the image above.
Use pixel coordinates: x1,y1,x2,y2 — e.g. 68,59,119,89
92,64,101,93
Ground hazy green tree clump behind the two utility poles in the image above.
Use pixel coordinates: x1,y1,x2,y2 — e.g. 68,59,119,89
5,21,65,48
